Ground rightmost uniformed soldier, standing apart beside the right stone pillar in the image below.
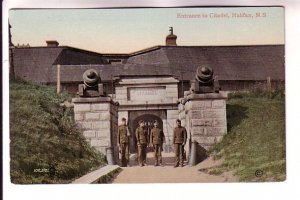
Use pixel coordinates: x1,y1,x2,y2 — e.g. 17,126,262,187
173,119,187,167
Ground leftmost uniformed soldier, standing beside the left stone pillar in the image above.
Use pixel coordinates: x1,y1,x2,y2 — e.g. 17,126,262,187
118,118,130,167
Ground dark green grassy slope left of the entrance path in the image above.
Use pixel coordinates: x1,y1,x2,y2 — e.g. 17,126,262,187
10,79,104,184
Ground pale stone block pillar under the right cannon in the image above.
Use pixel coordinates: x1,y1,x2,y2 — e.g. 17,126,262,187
178,92,227,156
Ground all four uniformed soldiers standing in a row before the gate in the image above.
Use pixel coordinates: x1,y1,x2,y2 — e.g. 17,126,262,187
118,118,187,167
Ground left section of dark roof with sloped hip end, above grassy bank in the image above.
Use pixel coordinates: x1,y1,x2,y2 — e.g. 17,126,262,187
12,46,108,83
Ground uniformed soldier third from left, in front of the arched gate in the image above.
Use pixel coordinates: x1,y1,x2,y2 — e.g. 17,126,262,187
150,120,165,166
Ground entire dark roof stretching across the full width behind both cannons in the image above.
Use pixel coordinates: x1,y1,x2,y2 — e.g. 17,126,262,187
14,45,285,82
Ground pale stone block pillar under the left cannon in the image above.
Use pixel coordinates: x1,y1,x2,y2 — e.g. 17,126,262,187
72,97,119,162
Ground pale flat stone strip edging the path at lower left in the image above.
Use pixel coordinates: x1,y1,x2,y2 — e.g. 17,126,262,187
71,165,120,184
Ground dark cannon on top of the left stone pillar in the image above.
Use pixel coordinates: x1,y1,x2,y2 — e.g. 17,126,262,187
78,69,106,97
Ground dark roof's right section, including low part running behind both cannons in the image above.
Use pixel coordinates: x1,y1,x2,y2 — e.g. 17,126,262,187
52,45,285,82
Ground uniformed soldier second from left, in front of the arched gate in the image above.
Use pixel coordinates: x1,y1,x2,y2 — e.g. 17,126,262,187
135,120,148,167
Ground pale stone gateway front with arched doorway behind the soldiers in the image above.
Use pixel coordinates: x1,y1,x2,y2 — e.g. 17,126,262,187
115,77,178,152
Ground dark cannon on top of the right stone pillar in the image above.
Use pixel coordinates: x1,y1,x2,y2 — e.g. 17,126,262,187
191,66,220,94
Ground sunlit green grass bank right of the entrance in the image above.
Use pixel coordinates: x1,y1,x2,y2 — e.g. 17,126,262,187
210,92,286,181
